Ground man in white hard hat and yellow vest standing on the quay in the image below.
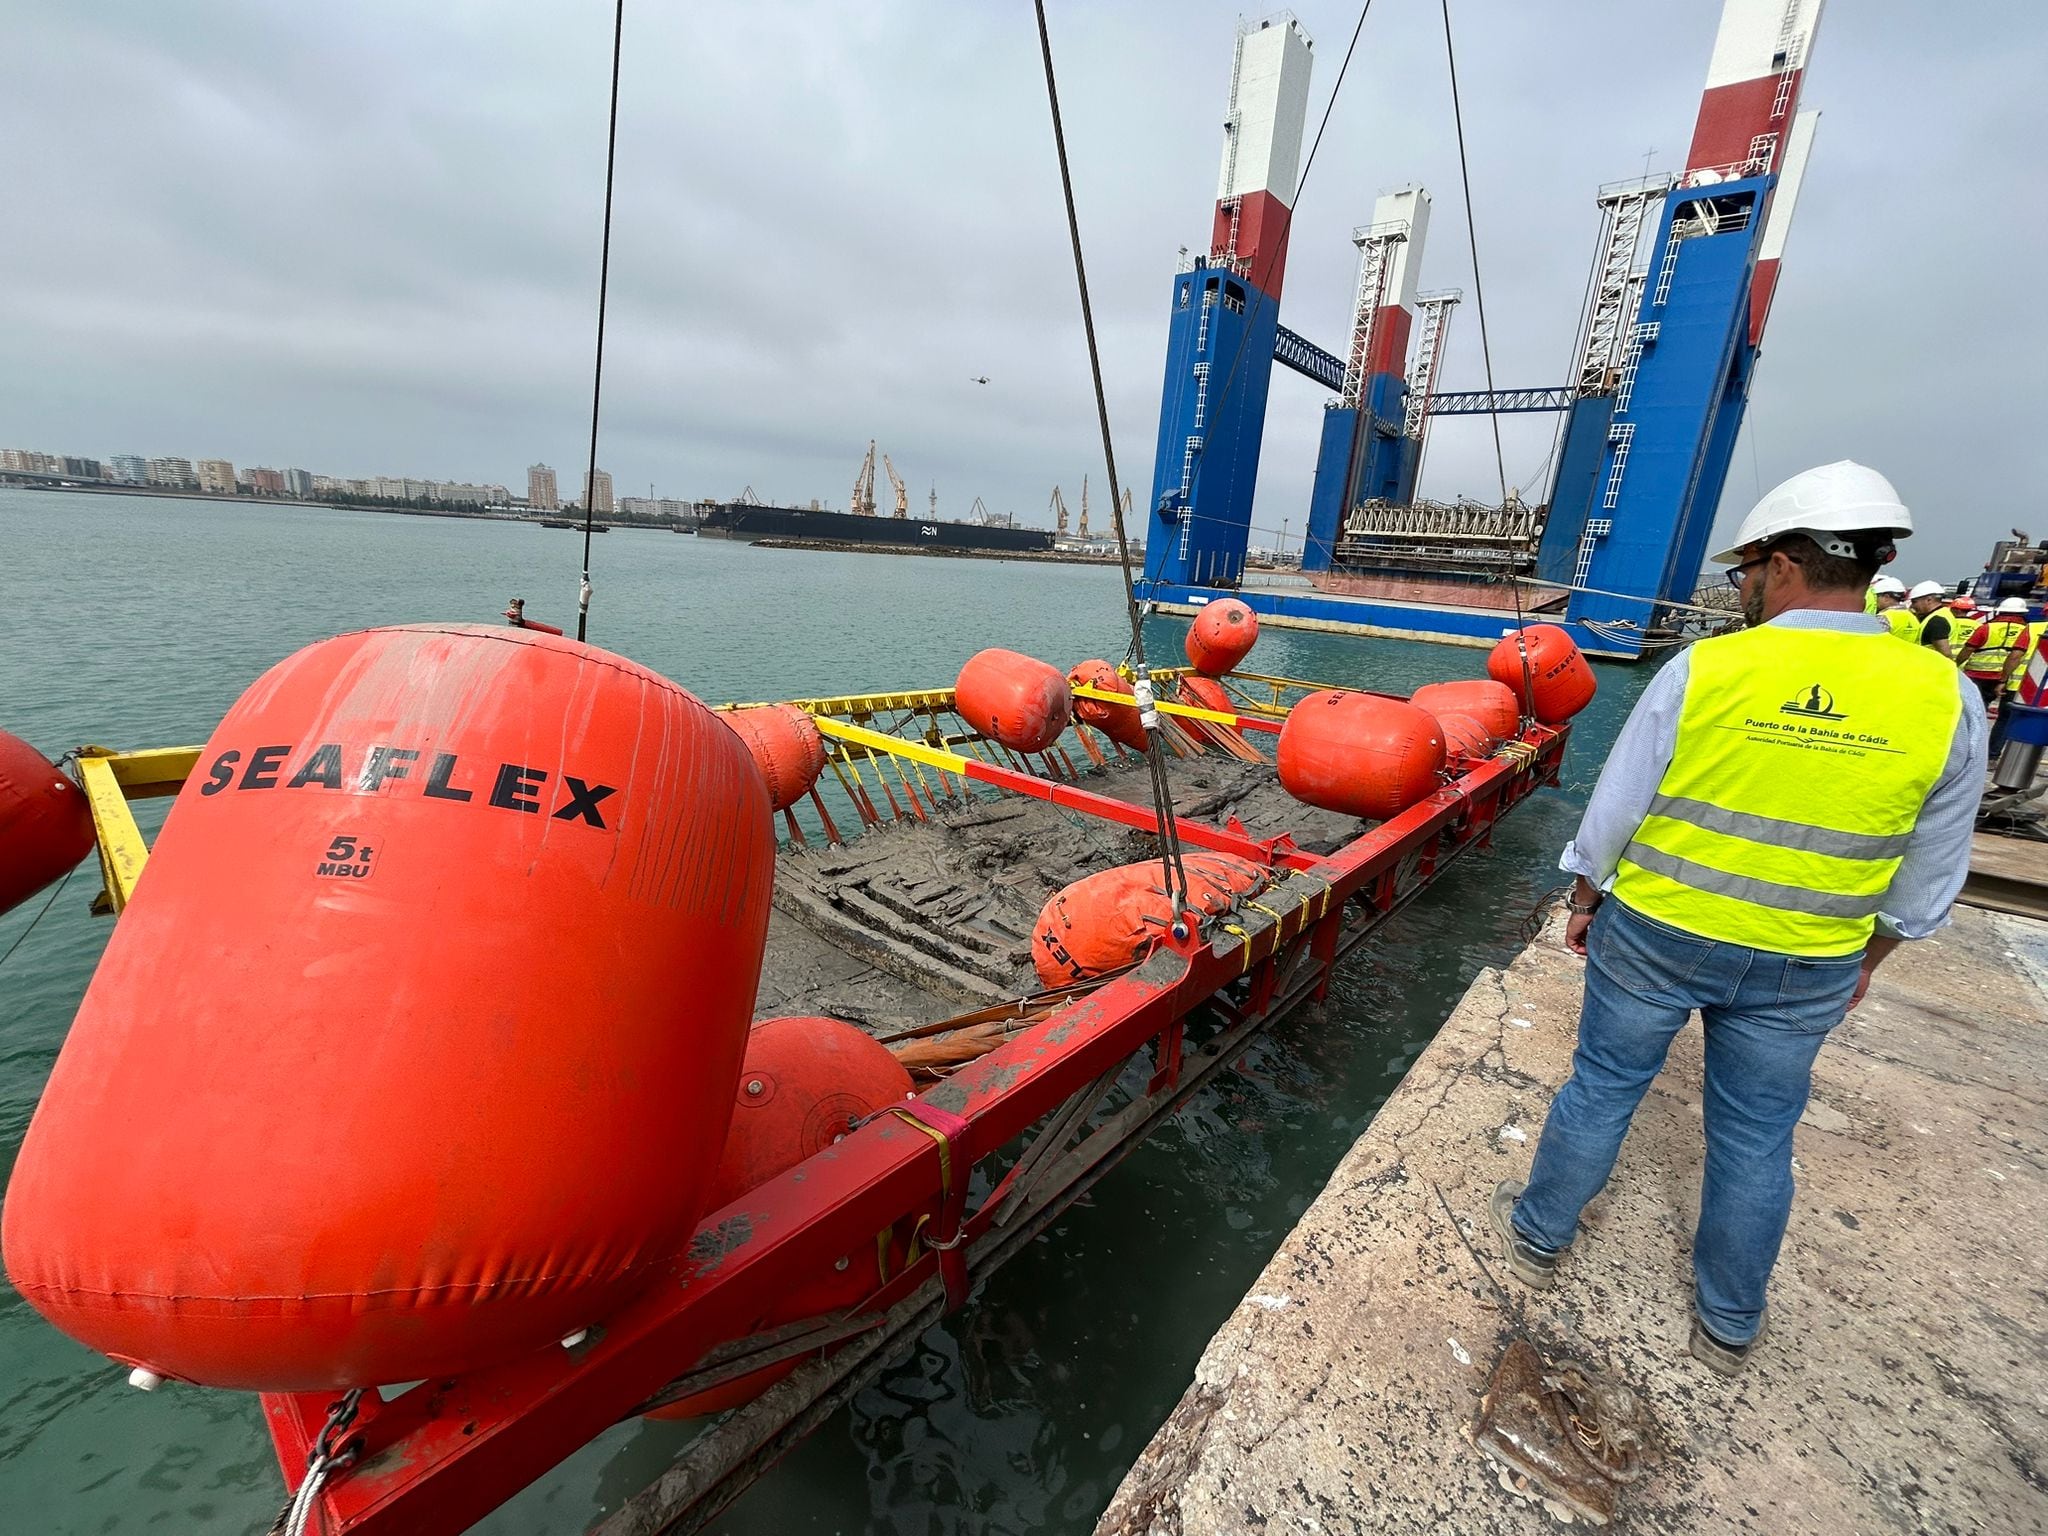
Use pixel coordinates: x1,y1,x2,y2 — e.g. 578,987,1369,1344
1489,461,1985,1374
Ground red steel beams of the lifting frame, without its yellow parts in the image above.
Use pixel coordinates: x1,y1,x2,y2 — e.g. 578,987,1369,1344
264,717,1569,1536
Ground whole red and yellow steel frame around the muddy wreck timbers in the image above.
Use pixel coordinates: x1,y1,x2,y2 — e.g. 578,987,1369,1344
68,674,1569,1536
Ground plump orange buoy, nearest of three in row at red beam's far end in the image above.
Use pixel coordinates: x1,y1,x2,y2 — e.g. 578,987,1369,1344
1274,692,1444,821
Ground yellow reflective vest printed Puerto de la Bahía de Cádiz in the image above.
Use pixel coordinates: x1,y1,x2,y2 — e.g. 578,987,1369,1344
1614,625,1962,954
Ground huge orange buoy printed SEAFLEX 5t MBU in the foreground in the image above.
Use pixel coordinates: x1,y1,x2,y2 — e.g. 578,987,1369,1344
0,625,774,1391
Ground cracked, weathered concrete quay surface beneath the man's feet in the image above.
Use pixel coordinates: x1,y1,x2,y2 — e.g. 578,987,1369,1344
1098,907,2048,1536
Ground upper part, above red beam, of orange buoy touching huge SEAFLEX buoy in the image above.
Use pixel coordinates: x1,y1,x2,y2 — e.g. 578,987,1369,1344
705,1018,911,1210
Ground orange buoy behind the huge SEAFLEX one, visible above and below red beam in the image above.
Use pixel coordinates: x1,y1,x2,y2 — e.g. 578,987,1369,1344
647,1018,911,1419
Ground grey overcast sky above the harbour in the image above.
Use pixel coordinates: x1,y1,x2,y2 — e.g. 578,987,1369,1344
0,0,2048,575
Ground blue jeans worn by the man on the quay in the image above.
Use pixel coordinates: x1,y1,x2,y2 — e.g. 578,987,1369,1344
1513,897,1862,1343
